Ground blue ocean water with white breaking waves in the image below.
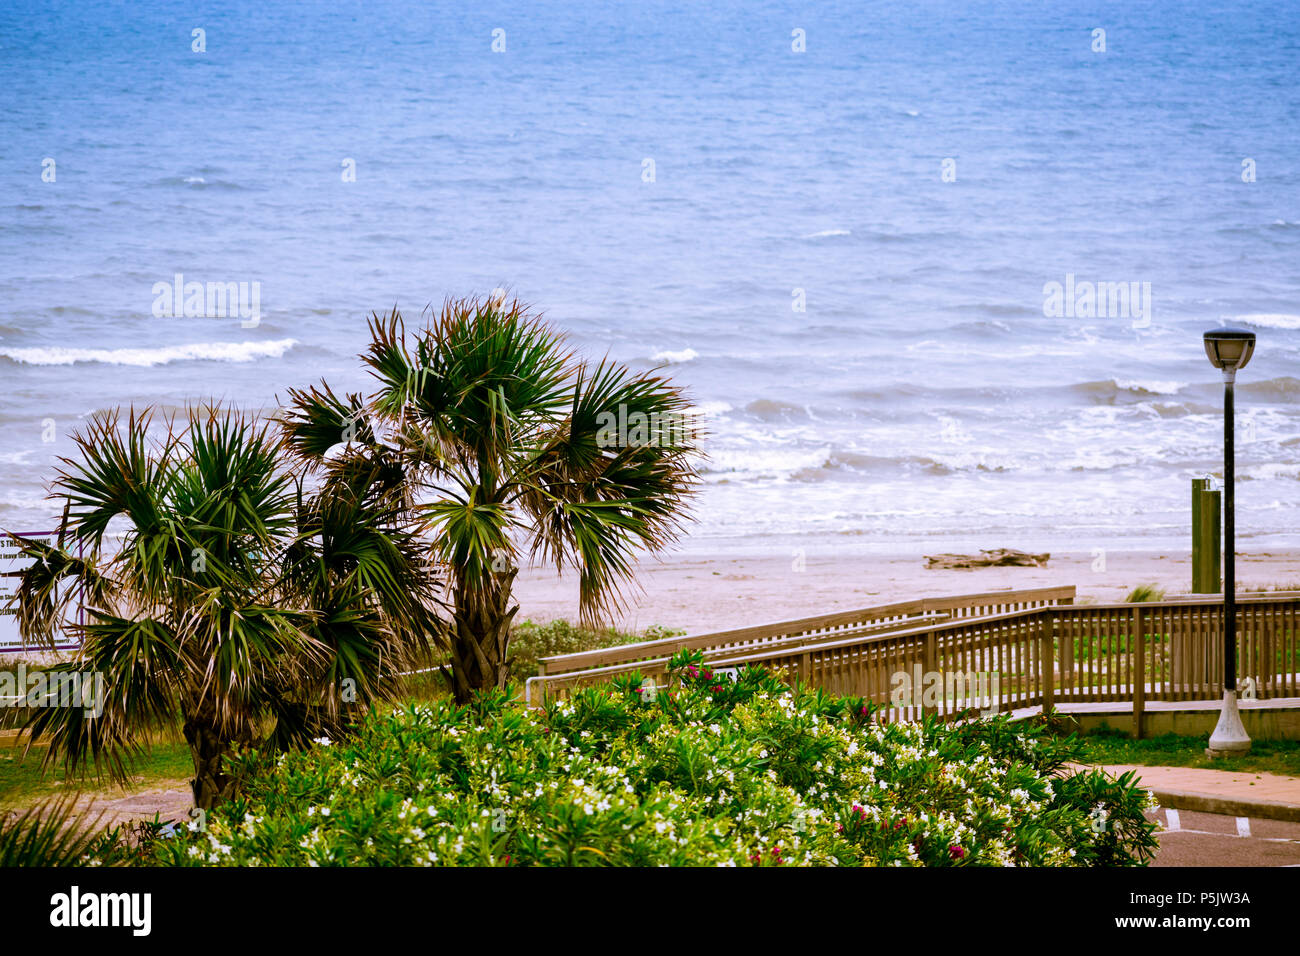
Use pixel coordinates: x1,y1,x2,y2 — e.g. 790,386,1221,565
0,0,1300,561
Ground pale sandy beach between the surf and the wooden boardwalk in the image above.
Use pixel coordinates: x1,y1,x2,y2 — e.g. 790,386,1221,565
515,551,1300,633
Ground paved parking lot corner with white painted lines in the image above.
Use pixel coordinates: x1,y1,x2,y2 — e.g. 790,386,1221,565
1148,808,1300,866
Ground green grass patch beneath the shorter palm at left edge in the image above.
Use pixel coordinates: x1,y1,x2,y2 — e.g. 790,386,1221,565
0,736,194,809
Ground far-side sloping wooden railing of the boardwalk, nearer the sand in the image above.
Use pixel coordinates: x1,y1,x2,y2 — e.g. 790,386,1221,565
527,587,1075,701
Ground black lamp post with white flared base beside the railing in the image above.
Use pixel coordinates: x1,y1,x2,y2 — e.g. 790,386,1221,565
1205,328,1255,757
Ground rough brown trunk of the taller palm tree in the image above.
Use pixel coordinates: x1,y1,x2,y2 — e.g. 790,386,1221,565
451,570,519,704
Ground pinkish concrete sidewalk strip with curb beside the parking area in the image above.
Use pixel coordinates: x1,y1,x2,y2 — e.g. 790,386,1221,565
1086,763,1300,823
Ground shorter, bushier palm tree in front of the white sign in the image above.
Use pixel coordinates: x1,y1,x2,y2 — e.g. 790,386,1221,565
6,406,436,808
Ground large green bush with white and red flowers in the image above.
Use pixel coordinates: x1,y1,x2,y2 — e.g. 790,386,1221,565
142,652,1156,866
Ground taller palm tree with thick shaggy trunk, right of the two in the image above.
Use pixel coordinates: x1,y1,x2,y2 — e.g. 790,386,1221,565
276,298,698,702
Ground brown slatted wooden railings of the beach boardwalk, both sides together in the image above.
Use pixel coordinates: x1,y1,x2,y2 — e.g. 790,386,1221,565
529,588,1300,728
